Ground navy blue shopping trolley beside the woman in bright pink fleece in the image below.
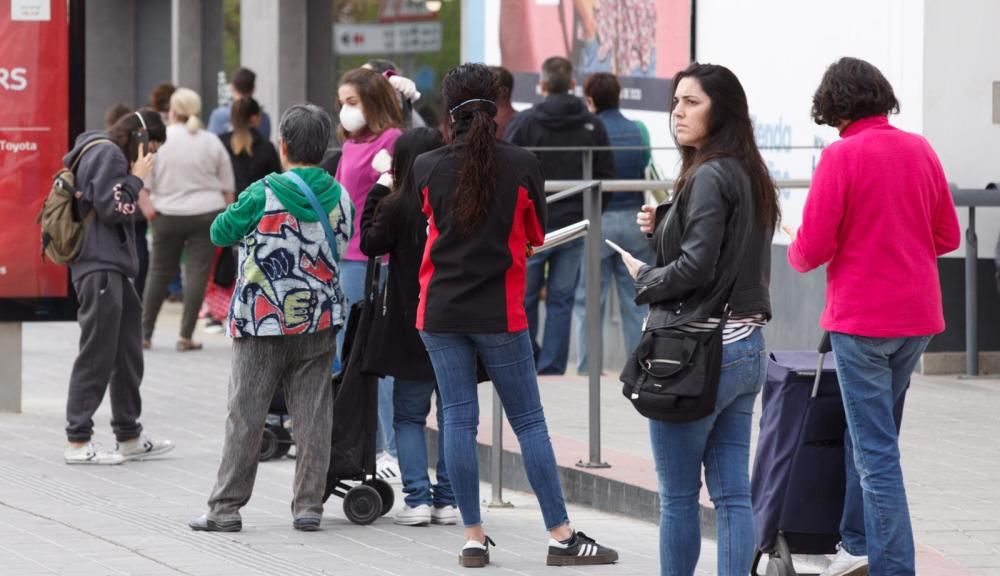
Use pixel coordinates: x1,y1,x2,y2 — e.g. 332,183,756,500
750,335,905,576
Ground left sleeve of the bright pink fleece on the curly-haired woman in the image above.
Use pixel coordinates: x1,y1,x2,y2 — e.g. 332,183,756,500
788,148,847,272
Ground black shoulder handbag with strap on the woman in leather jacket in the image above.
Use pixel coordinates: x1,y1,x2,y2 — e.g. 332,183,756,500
619,199,746,422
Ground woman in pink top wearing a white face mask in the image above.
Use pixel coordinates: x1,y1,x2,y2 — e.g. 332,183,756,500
335,68,403,482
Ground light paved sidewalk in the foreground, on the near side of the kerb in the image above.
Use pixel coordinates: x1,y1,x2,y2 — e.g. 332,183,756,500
0,306,715,576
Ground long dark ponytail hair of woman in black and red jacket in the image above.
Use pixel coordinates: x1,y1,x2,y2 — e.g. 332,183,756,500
441,63,500,234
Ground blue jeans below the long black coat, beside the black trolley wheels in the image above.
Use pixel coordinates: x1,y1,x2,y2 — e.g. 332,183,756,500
392,378,455,508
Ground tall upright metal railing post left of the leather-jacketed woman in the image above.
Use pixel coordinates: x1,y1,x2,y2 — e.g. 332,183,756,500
577,150,608,468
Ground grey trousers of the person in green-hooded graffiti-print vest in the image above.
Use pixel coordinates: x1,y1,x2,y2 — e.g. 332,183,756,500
208,330,336,520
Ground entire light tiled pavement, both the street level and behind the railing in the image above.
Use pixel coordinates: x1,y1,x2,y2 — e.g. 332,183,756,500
0,307,1000,576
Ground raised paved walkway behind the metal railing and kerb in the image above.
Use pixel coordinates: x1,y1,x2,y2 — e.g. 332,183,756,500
520,364,1000,576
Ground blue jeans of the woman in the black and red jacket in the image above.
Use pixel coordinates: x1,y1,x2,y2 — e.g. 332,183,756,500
420,330,569,530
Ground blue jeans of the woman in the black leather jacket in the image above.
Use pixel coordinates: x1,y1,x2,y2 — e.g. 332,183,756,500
649,329,767,576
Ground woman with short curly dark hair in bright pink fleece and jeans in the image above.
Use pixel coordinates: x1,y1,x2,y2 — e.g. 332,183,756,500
786,58,959,576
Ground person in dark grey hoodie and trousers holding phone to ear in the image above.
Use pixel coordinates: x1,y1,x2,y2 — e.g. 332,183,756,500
63,109,173,464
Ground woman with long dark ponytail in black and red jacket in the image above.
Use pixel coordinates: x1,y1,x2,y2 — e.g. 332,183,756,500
412,64,618,567
